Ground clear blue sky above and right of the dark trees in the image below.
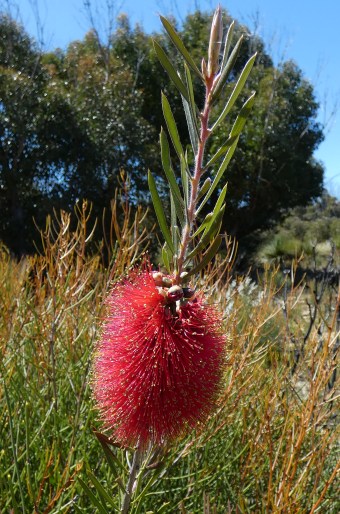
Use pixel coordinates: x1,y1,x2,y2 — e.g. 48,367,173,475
17,0,340,198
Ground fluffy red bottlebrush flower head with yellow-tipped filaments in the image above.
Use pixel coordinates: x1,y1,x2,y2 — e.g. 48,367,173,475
93,270,225,446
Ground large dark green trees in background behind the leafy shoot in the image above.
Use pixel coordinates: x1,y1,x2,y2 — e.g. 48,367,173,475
0,11,323,253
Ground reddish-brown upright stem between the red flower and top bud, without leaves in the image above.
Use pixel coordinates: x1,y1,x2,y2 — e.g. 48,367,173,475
174,77,214,284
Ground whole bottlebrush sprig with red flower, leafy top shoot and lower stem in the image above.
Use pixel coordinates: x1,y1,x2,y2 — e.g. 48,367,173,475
90,7,256,512
